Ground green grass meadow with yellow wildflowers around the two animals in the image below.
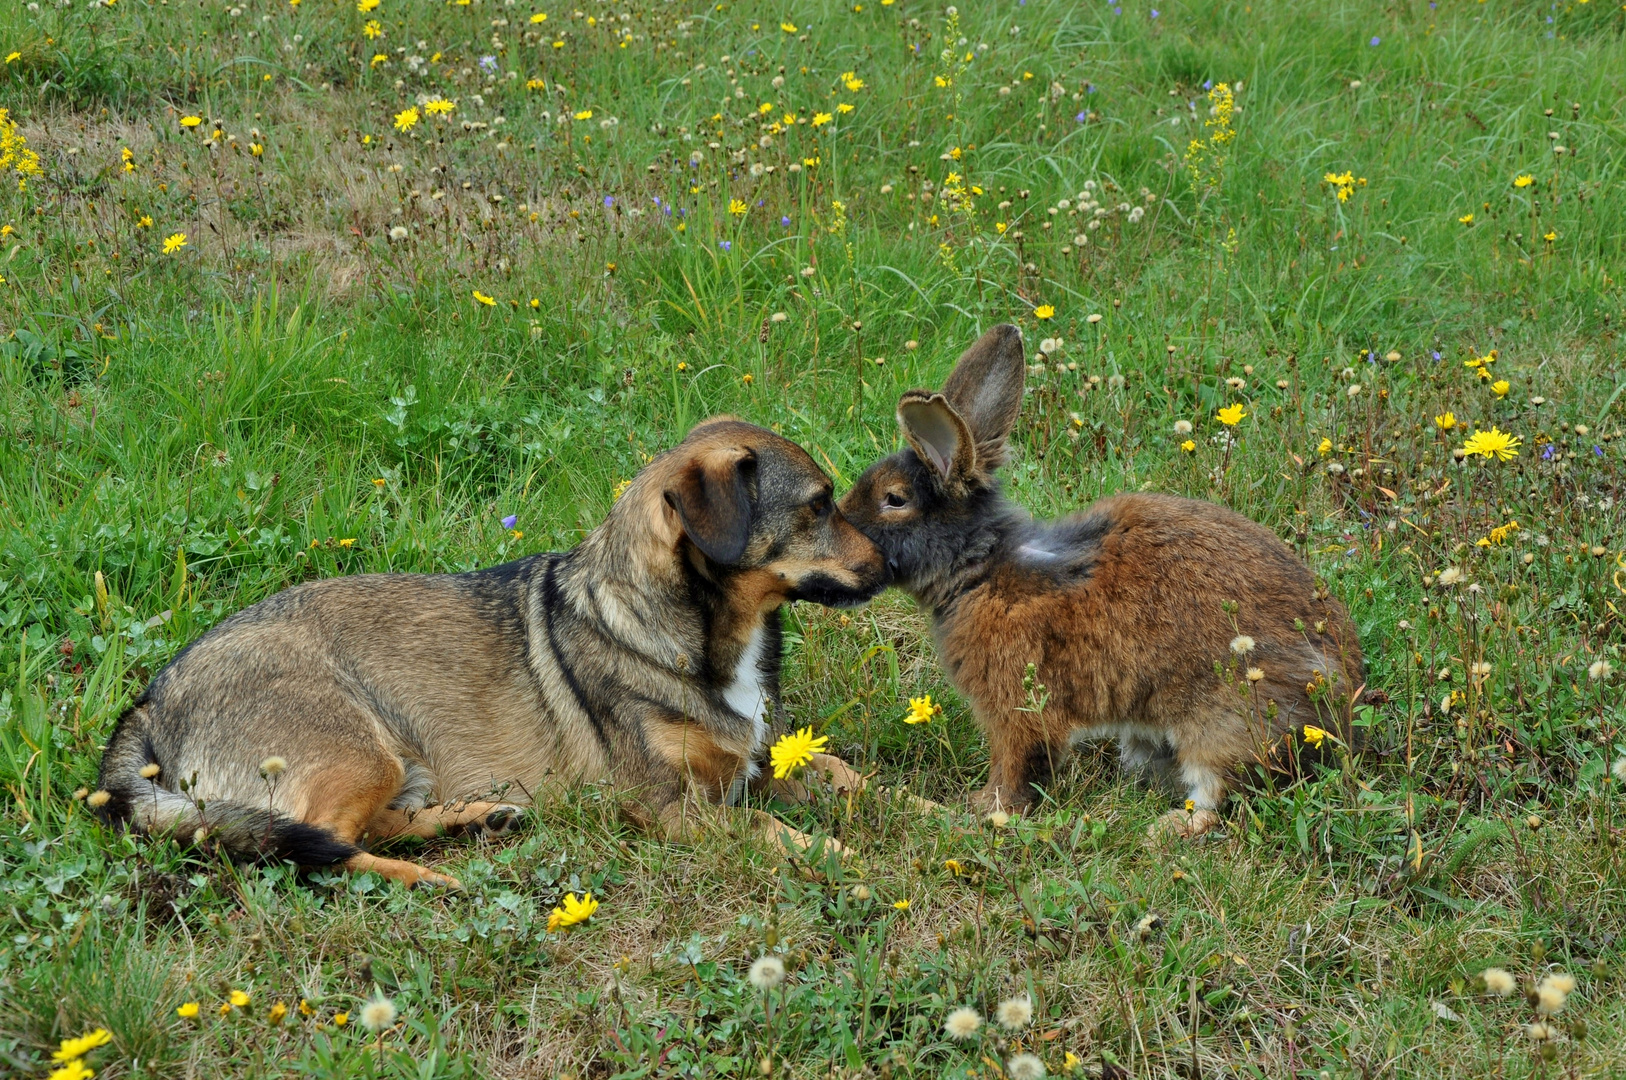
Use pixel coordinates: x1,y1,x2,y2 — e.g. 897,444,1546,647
0,0,1626,1080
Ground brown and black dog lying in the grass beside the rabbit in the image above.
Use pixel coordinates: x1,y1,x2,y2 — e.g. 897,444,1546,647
91,416,886,886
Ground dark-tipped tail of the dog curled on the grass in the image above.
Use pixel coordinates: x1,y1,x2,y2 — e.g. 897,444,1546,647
89,703,361,867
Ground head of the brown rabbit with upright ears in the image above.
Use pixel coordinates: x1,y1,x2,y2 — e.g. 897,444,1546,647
841,324,1028,594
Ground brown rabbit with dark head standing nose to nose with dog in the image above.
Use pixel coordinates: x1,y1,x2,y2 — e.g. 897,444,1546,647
841,325,1364,836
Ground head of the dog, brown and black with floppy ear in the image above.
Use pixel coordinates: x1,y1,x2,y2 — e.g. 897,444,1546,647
623,416,886,610
